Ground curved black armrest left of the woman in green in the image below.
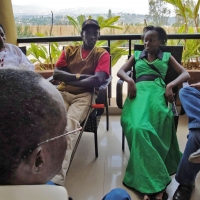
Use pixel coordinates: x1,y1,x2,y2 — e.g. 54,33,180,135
116,71,131,109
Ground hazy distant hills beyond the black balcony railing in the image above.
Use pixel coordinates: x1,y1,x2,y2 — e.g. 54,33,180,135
13,5,175,25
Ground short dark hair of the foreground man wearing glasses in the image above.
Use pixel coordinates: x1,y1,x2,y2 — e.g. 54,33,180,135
0,69,66,185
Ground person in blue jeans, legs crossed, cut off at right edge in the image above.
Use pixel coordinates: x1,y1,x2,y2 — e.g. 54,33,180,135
173,82,200,200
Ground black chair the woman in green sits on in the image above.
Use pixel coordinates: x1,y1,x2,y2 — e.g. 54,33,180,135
116,45,183,150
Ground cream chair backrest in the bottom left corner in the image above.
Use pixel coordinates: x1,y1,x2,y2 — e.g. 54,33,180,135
0,185,68,200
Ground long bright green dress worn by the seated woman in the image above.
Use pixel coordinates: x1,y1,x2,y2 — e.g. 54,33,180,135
121,51,181,194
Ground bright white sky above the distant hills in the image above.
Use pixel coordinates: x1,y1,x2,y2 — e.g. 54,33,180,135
11,0,172,14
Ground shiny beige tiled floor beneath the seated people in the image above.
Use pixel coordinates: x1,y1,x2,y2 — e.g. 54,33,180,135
65,115,200,200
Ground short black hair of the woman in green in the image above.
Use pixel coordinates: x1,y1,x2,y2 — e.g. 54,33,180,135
142,25,167,45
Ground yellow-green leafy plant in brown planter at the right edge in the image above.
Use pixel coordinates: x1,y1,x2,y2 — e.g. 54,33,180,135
164,0,200,84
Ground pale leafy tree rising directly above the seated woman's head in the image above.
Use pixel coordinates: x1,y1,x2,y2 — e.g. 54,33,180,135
146,0,171,26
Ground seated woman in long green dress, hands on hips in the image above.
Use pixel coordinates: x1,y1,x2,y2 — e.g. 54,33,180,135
117,26,189,200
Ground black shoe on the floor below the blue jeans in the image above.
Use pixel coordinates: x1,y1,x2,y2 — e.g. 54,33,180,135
173,185,194,200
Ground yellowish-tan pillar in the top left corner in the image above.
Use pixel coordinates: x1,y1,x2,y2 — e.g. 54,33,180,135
0,0,17,45
